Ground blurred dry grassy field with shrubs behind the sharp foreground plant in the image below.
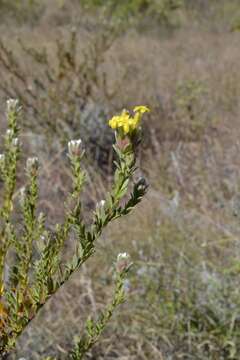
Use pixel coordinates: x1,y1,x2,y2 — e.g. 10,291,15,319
0,0,240,360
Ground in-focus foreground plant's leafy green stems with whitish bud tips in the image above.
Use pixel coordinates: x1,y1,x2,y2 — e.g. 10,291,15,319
0,100,147,359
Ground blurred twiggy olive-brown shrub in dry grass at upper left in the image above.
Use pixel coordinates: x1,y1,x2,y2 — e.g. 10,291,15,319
0,27,120,164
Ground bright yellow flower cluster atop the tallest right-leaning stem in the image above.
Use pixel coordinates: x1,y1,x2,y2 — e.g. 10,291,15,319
109,105,150,135
